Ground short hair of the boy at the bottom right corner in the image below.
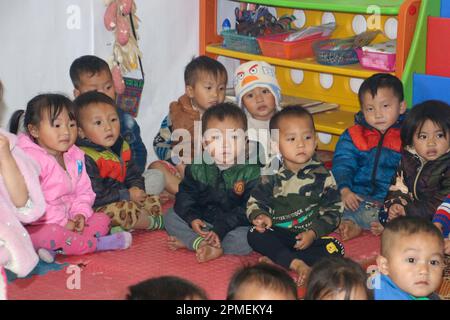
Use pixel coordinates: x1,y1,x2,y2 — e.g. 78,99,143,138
381,216,444,257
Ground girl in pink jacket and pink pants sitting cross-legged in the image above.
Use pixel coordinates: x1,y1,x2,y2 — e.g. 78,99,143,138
18,94,131,262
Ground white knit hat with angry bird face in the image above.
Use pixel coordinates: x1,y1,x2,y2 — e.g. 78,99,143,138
233,61,281,108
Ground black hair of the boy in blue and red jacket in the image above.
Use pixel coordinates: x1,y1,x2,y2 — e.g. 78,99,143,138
358,73,405,107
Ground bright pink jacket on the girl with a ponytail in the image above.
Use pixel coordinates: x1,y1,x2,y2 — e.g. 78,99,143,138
18,134,95,227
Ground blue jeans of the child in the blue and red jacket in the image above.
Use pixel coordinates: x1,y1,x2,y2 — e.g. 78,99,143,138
342,195,382,230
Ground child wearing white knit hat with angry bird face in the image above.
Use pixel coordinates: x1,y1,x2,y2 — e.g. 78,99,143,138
234,61,281,165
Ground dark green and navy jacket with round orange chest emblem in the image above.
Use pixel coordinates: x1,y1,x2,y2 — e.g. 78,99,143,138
174,164,260,239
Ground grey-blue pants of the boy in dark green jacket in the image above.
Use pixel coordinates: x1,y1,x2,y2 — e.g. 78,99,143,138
164,209,252,255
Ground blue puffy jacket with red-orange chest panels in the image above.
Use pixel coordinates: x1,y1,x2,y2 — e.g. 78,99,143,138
332,112,405,201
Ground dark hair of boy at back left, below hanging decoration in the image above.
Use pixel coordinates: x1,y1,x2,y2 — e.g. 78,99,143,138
69,55,111,89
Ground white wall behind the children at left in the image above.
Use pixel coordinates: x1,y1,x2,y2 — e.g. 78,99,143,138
0,0,198,161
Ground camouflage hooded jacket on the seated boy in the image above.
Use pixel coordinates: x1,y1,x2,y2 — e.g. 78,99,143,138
247,158,343,237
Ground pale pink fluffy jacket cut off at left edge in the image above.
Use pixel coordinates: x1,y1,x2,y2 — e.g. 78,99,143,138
0,129,45,282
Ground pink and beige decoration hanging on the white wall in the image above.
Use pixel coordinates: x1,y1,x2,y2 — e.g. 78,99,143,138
104,0,144,116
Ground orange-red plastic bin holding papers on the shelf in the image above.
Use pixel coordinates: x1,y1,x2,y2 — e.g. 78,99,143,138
257,33,329,60
